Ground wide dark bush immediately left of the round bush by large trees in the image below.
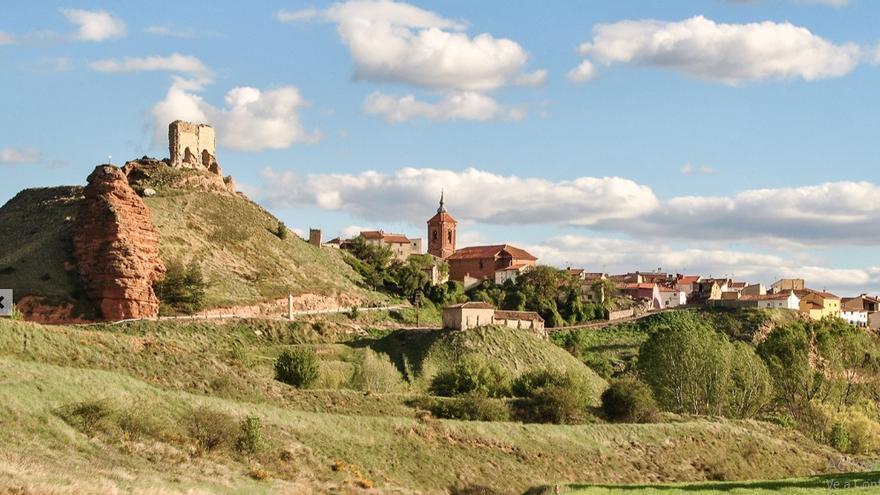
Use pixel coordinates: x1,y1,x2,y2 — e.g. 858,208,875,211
511,369,592,424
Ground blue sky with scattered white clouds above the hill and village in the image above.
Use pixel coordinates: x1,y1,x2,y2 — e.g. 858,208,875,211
0,0,880,294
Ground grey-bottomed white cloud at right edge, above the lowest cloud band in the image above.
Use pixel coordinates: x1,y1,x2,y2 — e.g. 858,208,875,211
598,182,880,245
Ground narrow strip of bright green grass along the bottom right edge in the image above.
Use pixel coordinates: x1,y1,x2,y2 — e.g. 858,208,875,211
526,471,880,495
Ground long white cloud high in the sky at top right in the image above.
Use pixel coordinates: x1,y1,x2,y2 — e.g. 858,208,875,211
579,16,860,84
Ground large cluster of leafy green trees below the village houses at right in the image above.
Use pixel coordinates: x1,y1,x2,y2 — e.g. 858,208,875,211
630,312,880,453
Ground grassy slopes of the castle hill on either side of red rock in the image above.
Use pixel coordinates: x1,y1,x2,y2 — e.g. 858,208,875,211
0,165,380,318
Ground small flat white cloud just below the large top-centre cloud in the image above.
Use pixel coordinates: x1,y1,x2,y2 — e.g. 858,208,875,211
364,91,525,122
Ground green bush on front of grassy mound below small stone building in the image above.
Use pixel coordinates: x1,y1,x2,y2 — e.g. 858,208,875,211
430,356,510,397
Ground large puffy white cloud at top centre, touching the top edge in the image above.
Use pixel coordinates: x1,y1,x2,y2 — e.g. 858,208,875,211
278,0,546,91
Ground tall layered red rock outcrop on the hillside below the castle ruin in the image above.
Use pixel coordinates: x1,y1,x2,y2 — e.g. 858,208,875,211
73,165,165,320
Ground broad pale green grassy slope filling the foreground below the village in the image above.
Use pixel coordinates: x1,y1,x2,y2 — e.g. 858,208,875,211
0,320,853,494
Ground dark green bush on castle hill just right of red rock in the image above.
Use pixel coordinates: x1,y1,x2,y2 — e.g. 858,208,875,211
153,260,208,314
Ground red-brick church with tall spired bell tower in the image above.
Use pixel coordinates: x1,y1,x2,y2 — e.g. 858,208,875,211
428,194,538,286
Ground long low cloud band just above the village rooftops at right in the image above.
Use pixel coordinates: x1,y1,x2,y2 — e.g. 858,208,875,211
528,235,880,292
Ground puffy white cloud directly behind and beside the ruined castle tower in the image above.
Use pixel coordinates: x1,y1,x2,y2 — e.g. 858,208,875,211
151,79,320,151
